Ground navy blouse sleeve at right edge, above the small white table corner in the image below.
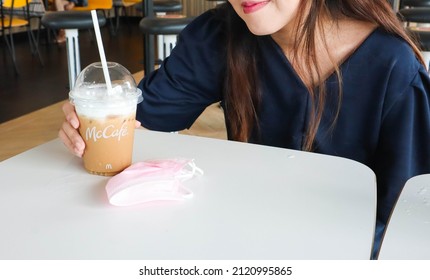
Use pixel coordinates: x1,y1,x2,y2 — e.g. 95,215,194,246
373,64,430,224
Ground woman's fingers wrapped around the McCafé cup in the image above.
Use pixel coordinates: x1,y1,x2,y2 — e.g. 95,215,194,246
58,102,85,157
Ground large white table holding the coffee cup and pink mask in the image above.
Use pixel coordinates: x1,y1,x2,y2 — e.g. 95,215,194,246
0,130,376,260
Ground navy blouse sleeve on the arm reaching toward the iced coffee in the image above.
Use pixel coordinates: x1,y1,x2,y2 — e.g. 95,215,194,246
136,10,225,131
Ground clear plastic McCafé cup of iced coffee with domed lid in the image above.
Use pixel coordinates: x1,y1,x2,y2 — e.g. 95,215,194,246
69,62,142,176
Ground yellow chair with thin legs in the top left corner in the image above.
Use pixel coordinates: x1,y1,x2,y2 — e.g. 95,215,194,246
0,0,43,74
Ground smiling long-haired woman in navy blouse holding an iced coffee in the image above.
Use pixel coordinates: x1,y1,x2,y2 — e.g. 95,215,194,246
59,0,430,258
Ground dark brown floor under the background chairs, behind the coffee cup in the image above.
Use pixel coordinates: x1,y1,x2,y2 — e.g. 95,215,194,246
0,18,143,123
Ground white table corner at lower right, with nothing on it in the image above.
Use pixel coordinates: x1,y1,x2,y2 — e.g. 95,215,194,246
378,174,430,260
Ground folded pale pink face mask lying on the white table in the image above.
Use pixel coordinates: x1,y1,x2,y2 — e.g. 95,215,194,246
106,158,203,206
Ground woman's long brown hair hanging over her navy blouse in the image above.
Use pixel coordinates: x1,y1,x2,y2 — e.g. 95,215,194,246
220,0,424,151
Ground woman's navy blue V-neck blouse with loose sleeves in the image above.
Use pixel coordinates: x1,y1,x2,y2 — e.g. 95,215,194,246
137,9,430,241
